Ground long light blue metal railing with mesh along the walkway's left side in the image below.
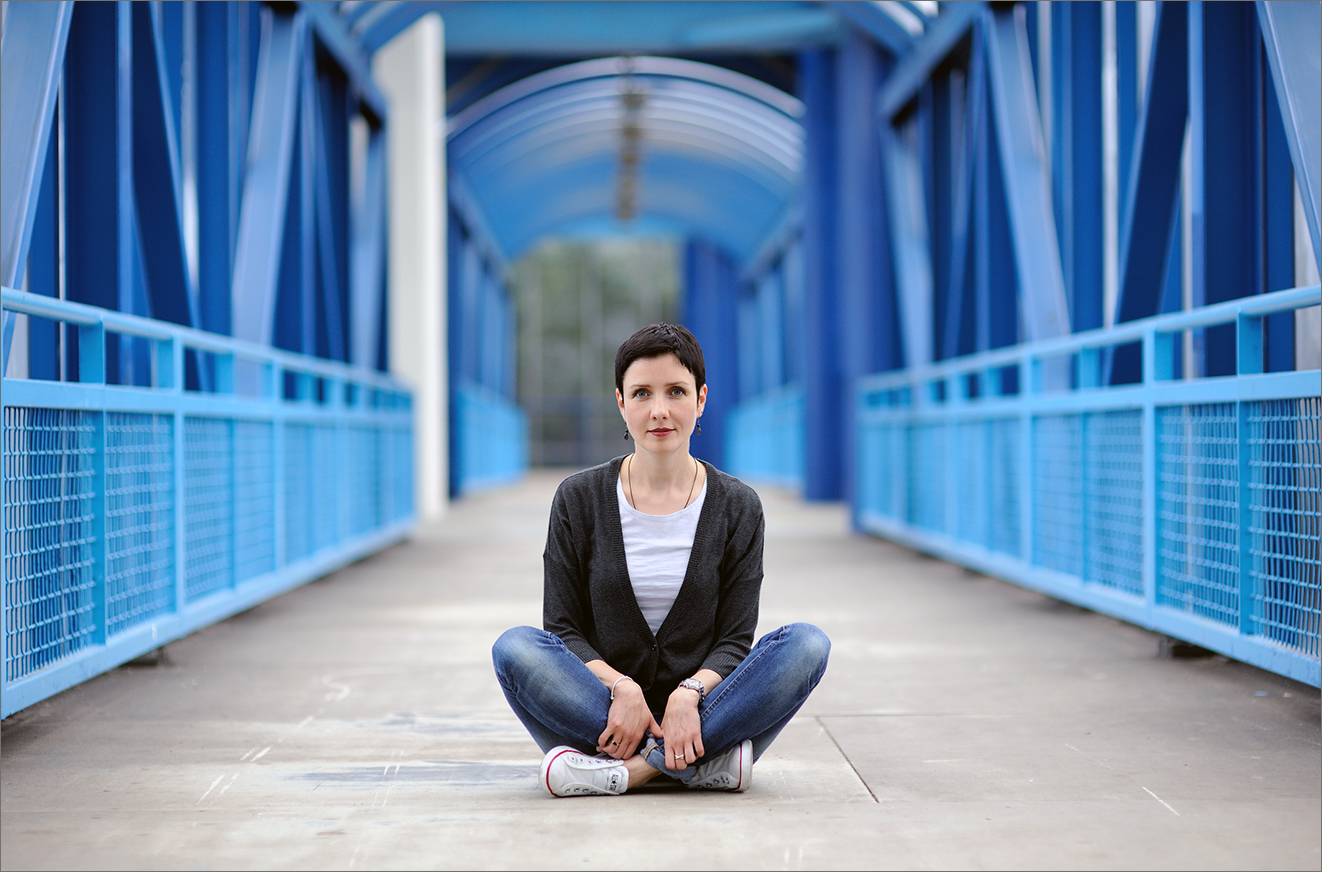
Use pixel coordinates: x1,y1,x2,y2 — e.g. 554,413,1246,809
0,288,414,716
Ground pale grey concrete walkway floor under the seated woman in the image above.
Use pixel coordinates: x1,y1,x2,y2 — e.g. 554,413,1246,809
0,474,1322,869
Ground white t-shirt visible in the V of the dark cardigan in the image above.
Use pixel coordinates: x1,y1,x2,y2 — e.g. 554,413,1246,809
615,478,707,636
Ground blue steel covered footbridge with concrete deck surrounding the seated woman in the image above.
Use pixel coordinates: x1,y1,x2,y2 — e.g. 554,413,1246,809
0,0,1322,868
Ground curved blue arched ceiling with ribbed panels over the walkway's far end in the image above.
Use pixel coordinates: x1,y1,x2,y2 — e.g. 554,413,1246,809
447,57,804,260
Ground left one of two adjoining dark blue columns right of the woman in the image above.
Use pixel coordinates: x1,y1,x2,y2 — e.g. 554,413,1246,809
798,50,850,499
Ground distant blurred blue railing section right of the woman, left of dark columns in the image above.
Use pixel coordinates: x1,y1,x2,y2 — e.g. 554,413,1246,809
726,384,804,489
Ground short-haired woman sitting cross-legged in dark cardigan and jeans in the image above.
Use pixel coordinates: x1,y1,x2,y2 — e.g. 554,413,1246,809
492,324,830,797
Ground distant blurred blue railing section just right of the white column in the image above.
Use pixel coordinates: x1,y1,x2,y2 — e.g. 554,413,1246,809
451,382,527,495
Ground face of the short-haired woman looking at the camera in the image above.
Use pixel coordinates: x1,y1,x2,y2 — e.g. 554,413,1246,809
615,354,707,454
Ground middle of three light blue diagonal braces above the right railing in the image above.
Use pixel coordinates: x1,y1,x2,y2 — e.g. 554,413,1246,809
984,7,1069,342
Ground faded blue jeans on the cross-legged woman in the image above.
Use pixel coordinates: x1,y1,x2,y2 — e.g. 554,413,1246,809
492,624,830,781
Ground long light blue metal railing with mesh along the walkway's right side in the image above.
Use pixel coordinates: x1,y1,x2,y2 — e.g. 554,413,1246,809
857,287,1322,686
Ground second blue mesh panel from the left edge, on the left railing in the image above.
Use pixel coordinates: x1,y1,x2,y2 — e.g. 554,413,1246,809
106,412,175,636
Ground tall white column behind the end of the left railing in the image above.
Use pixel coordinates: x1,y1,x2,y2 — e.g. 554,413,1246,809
371,13,449,521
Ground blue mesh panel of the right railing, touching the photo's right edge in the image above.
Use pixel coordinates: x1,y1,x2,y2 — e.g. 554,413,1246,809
1247,396,1322,657
